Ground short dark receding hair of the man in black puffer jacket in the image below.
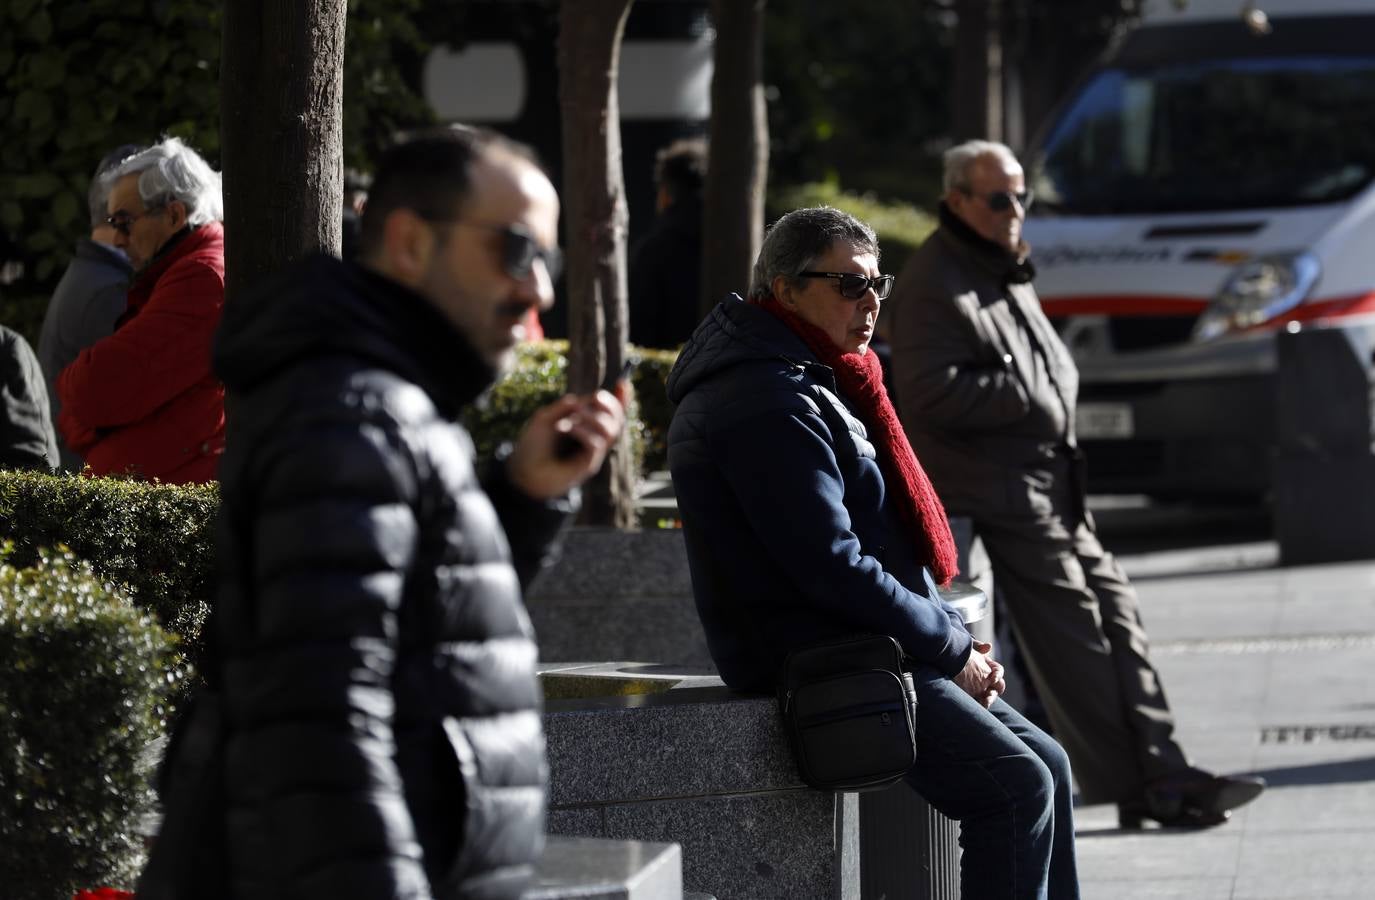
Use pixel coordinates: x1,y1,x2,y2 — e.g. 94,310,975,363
359,125,539,256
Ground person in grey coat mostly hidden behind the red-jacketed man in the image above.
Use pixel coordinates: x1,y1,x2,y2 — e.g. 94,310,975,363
39,144,142,471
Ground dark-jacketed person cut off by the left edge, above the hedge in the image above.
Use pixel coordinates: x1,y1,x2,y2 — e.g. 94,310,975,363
0,326,58,471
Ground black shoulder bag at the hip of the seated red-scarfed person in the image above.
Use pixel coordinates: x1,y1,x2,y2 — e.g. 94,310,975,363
778,635,917,791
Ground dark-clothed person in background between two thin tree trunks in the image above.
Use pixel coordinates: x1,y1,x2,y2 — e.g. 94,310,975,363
630,137,707,350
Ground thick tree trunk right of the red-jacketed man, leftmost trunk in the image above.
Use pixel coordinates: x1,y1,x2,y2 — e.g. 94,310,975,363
220,0,348,302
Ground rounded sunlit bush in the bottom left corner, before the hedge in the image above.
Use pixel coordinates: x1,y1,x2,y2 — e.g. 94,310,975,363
0,555,177,900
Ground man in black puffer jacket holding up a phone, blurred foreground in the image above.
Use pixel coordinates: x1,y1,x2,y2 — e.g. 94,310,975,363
212,128,623,900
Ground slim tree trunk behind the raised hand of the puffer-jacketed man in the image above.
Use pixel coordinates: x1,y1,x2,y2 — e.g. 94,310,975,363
558,0,637,528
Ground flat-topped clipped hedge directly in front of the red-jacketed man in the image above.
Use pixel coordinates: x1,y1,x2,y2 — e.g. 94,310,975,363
0,471,220,651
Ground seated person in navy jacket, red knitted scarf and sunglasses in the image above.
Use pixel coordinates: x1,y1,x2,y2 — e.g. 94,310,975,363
668,207,1078,900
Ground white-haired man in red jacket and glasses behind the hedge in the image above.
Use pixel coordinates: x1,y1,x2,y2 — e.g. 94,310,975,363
58,137,224,484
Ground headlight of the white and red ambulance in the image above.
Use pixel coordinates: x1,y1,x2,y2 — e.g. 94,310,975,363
1194,253,1321,341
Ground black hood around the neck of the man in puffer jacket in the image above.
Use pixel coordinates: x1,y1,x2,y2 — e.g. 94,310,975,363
215,254,496,418
